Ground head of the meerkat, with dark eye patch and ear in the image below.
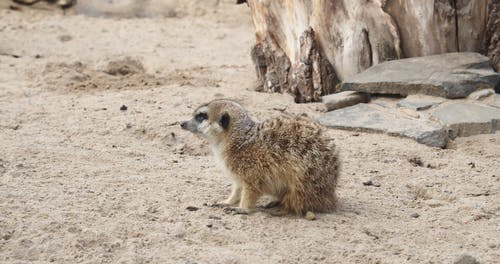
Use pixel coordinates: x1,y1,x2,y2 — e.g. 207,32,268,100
181,100,254,143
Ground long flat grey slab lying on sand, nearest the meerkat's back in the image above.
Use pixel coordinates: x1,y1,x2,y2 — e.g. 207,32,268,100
318,104,447,148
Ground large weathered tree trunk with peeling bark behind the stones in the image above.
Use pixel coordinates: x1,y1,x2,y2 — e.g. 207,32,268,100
247,0,500,102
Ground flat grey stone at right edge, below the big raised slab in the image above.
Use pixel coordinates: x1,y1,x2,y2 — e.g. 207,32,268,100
431,102,500,139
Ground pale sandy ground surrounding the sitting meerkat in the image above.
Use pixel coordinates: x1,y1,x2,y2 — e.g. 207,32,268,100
0,1,500,263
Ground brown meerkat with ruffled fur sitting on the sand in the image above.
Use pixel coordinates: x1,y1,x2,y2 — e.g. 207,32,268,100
181,99,339,214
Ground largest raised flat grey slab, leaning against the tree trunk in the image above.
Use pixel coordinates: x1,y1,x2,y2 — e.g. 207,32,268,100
341,52,500,98
